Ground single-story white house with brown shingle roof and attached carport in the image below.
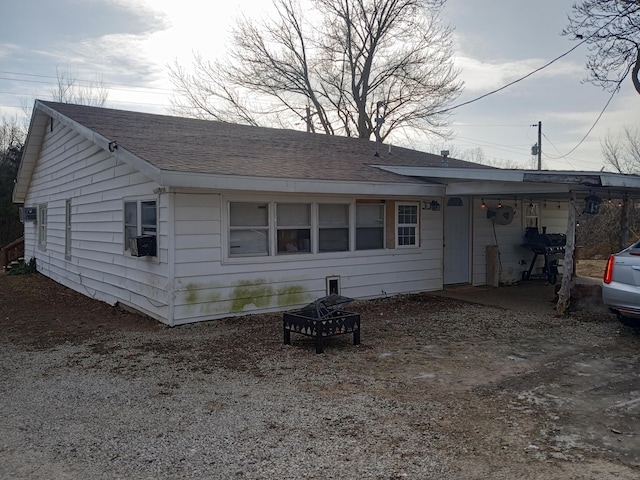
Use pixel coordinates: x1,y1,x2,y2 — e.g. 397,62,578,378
14,101,640,325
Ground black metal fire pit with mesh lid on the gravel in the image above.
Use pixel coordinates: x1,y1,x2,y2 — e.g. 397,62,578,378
283,294,360,353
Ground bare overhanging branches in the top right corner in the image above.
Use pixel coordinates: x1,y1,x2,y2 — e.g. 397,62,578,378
562,0,640,93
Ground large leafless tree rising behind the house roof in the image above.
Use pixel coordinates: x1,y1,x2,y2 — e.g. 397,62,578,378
169,0,462,141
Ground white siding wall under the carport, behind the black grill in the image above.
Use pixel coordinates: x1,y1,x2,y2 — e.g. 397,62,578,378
473,198,568,285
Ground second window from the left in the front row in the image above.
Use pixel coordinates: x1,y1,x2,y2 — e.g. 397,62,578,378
276,203,311,255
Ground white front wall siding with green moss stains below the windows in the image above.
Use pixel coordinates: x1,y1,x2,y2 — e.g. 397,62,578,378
169,193,442,324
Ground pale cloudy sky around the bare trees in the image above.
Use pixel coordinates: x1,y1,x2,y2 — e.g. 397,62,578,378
0,0,640,171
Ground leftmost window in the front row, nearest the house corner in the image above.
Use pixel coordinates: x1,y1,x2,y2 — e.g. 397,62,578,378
229,202,269,257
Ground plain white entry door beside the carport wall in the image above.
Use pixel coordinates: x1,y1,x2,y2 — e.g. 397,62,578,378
443,197,471,285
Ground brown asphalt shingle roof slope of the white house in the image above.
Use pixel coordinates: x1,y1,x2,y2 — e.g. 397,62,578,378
42,102,482,183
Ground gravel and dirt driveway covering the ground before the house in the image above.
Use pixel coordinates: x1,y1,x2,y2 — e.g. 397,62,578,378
0,275,640,480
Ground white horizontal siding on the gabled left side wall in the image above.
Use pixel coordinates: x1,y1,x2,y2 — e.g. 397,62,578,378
25,122,169,319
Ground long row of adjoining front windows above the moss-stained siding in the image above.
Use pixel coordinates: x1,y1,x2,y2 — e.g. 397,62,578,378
228,200,420,258
